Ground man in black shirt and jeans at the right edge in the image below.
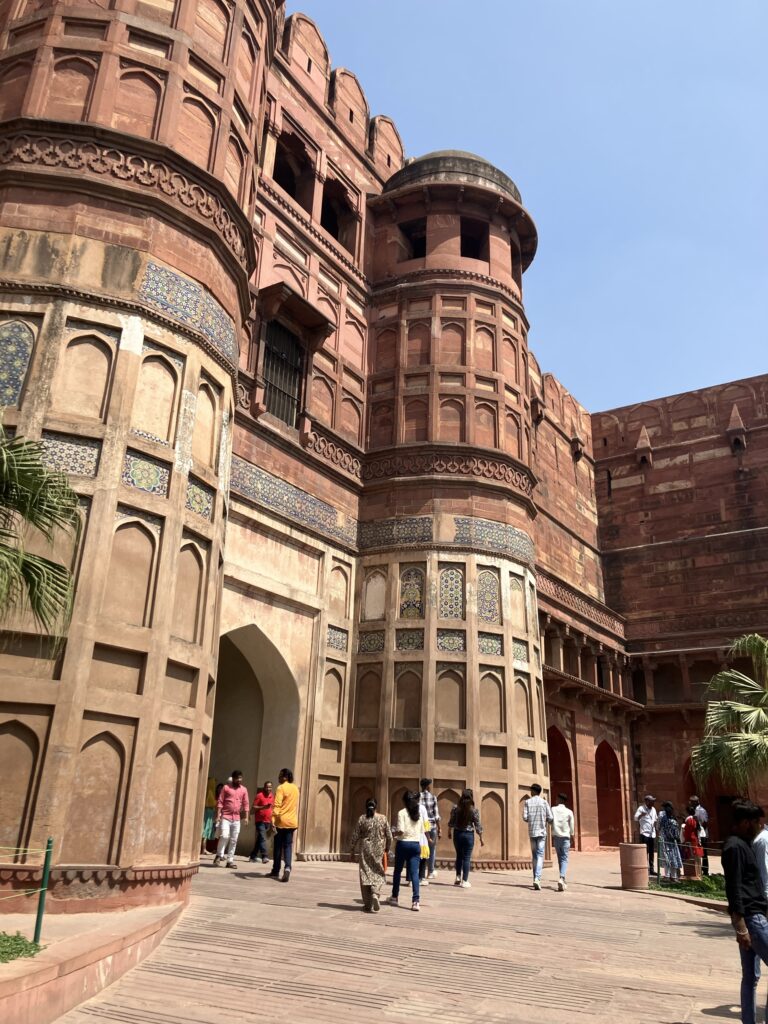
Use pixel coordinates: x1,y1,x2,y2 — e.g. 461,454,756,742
723,800,768,1024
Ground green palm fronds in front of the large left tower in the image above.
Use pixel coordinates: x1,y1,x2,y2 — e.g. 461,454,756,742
0,425,80,636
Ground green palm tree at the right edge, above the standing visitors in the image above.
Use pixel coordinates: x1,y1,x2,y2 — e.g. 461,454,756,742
691,633,768,794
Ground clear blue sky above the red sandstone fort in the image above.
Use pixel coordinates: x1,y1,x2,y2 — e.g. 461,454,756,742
288,0,768,411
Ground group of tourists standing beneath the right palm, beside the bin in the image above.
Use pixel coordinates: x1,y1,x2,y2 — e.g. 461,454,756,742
635,794,710,883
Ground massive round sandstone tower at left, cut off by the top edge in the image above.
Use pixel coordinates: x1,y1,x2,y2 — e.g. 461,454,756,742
0,0,282,909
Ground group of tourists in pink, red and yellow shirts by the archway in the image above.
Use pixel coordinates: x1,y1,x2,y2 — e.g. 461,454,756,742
203,768,299,882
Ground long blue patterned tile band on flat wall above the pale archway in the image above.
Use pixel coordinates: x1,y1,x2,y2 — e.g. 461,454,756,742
231,456,357,546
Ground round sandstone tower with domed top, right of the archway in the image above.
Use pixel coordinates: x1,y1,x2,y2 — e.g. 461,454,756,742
348,152,548,865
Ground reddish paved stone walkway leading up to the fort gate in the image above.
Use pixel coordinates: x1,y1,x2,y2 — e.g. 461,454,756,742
59,854,745,1024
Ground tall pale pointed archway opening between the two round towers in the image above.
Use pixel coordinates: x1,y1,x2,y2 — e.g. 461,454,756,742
208,625,299,853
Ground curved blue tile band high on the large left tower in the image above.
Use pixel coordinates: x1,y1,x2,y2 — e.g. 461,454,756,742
139,260,238,369
